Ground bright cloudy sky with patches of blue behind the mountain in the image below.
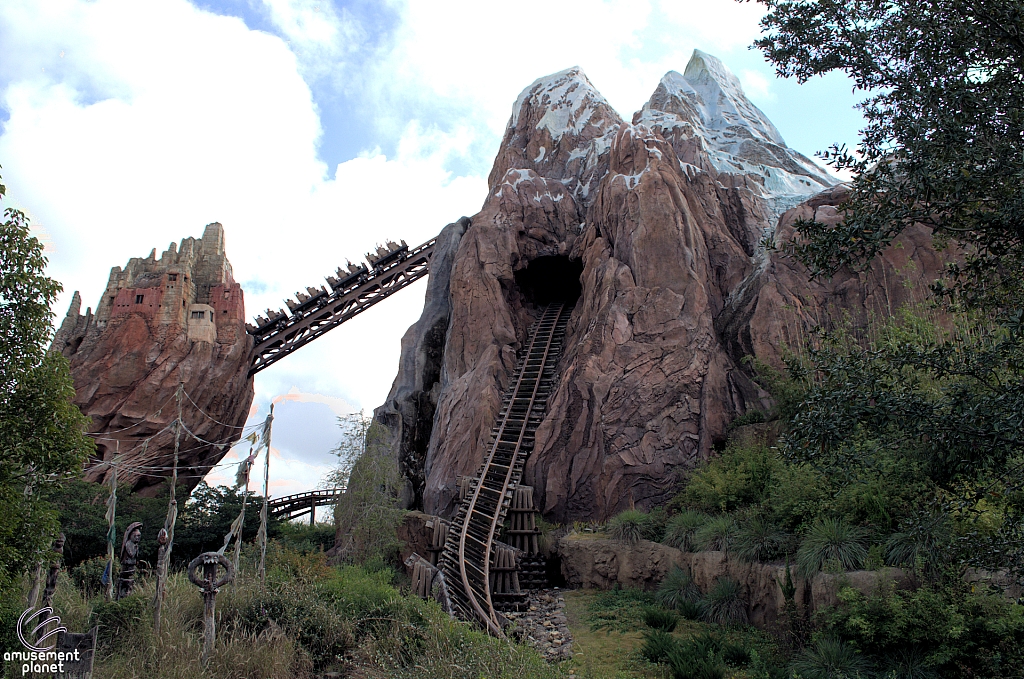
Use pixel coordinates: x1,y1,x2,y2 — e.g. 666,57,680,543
0,0,861,496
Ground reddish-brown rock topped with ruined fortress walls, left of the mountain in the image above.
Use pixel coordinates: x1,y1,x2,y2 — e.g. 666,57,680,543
53,223,254,496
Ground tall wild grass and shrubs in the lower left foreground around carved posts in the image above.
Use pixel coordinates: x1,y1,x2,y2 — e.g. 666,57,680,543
39,544,563,679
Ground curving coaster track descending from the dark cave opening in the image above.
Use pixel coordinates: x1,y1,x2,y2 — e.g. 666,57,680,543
441,302,571,637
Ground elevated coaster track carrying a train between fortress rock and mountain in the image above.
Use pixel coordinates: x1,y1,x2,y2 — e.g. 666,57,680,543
248,239,437,377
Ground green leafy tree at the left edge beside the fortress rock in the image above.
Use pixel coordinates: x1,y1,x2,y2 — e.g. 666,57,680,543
0,170,93,640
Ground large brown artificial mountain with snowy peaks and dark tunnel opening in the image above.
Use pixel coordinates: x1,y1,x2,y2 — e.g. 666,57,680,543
376,51,941,522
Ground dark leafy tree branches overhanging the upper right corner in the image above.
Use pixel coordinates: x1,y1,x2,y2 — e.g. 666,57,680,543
756,0,1024,308
